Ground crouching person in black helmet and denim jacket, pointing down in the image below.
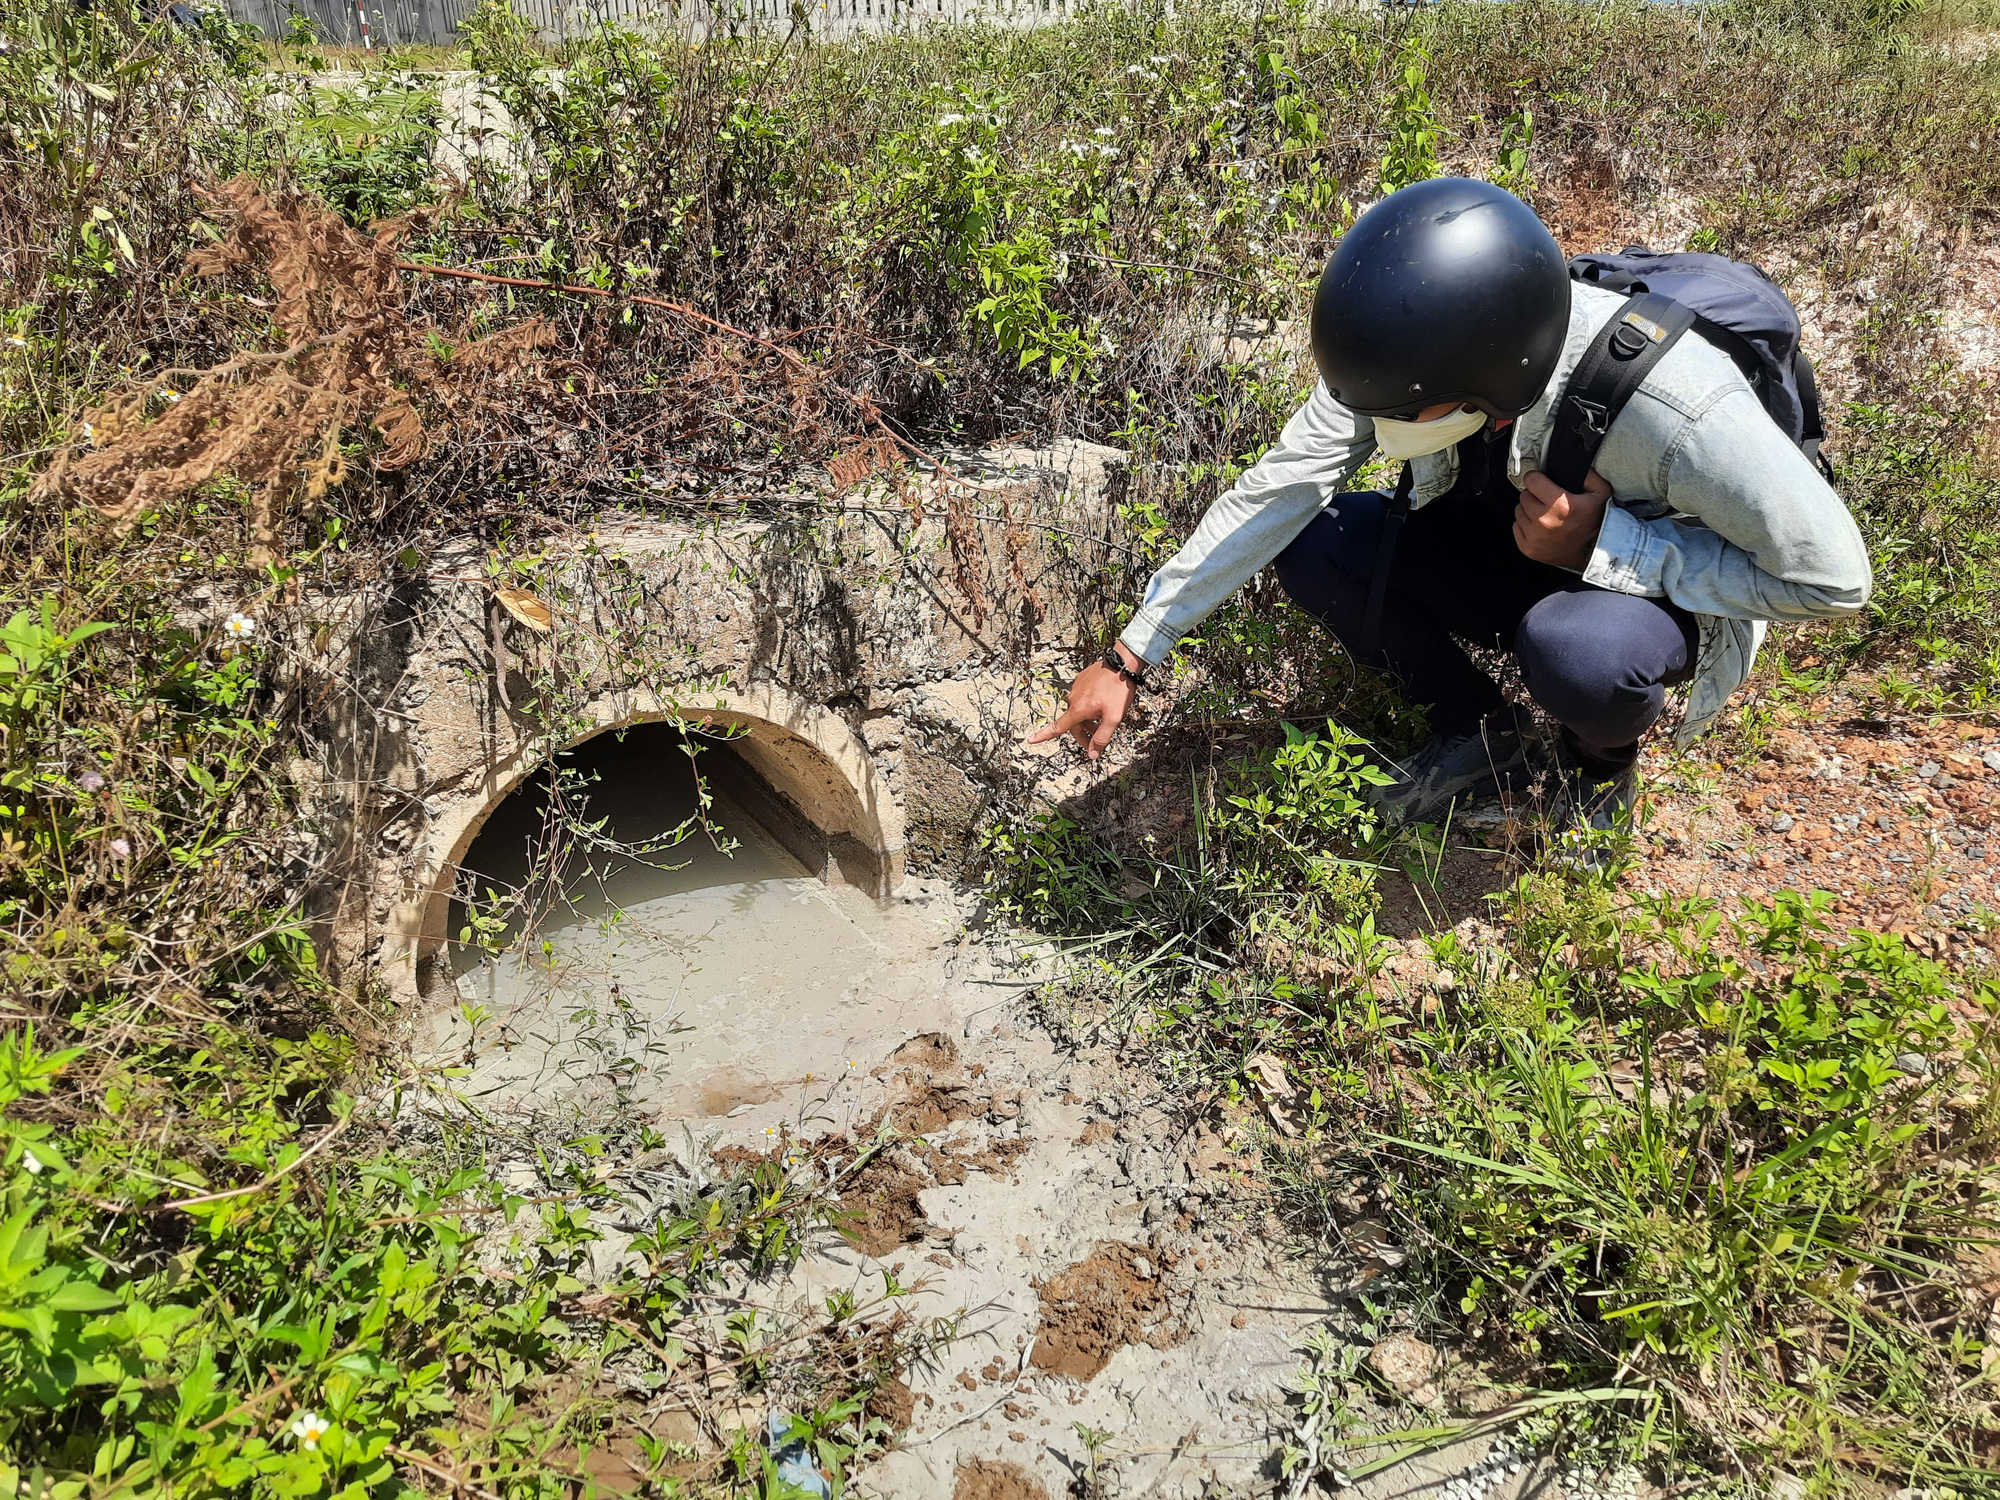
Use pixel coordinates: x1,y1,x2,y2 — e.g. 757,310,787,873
1030,178,1870,848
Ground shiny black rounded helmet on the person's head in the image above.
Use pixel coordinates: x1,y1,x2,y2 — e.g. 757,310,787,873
1312,178,1570,418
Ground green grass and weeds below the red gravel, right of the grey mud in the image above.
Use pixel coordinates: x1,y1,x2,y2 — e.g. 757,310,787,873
996,788,2000,1496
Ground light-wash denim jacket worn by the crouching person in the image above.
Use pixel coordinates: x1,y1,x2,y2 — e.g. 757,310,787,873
1120,286,1872,746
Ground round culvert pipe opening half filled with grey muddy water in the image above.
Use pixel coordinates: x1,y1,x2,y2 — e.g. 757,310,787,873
410,722,942,1122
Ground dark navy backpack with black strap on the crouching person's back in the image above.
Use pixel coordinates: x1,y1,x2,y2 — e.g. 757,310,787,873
1542,244,1832,490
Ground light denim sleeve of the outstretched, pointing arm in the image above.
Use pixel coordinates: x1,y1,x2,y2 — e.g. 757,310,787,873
1118,386,1374,662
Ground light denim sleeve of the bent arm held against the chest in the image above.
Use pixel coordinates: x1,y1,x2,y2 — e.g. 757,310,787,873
1584,390,1872,620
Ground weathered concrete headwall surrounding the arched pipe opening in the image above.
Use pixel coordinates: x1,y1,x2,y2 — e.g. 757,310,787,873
304,442,1134,996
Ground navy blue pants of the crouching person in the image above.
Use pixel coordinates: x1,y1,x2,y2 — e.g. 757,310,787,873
1276,492,1696,774
